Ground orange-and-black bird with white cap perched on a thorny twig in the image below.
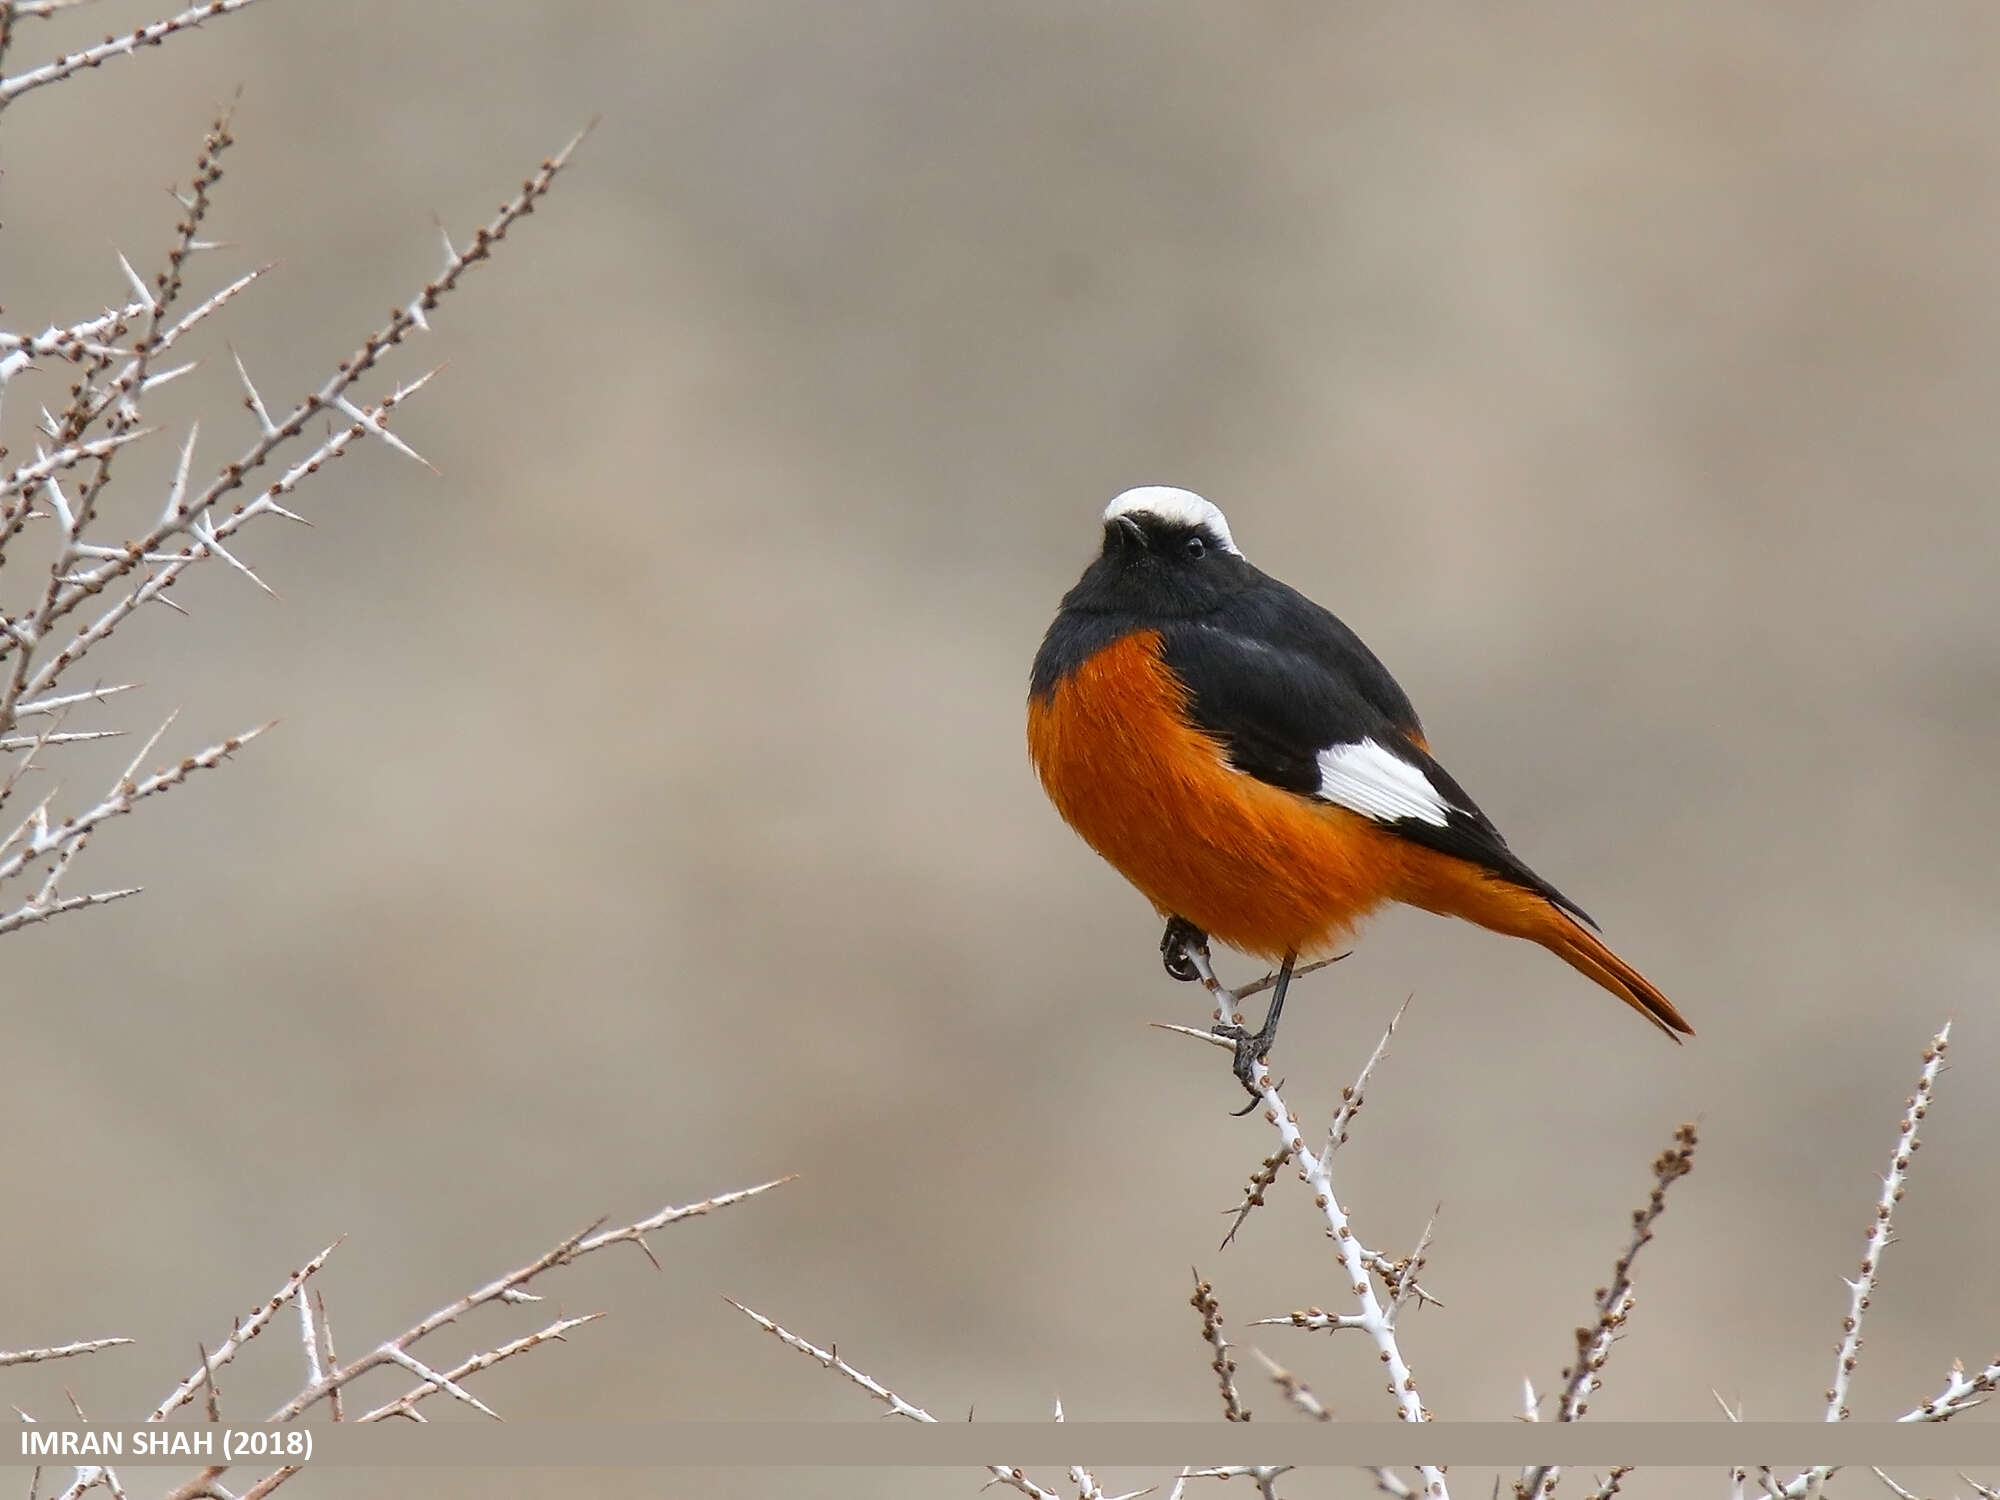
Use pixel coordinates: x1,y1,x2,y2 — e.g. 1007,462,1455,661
1028,484,1694,1098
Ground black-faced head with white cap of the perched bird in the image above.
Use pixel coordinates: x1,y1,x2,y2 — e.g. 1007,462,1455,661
1062,486,1262,620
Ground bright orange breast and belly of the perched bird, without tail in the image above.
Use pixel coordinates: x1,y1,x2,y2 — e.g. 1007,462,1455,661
1028,630,1406,960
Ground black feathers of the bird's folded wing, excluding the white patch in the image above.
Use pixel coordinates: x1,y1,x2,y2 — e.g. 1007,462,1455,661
1160,620,1596,926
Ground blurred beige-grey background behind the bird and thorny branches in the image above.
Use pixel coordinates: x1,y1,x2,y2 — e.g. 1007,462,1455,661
0,0,2000,1496
